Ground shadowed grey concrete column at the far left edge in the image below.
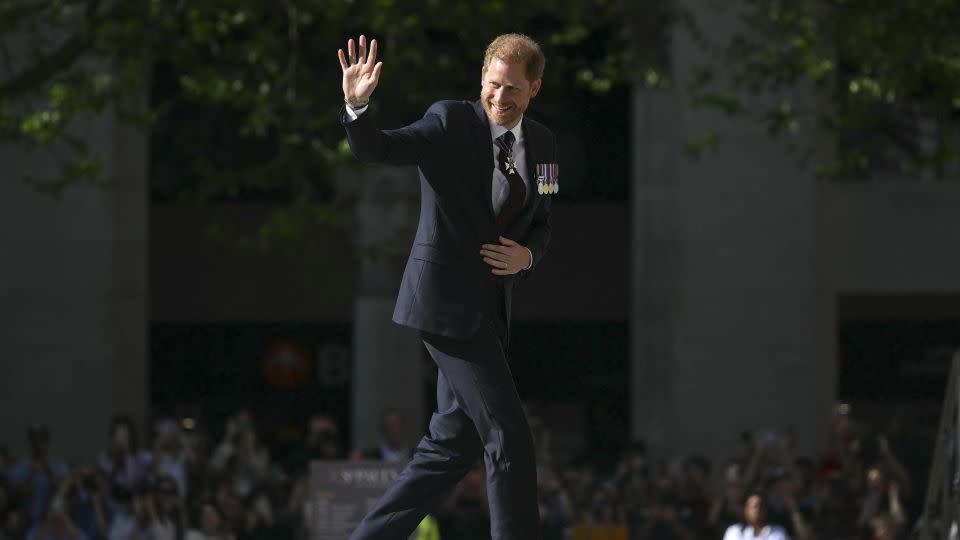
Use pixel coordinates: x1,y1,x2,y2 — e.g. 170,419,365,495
0,105,148,462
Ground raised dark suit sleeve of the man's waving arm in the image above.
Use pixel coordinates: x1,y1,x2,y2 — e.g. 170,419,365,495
340,103,446,165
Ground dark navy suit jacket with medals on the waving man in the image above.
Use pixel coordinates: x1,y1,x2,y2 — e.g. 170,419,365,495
342,101,557,338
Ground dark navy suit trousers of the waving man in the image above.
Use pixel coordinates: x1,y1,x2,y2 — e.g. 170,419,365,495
350,314,540,540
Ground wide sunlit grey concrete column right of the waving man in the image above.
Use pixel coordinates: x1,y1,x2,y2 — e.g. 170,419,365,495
631,0,827,460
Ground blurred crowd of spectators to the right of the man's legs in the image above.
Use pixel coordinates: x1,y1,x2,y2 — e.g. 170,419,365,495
540,404,918,540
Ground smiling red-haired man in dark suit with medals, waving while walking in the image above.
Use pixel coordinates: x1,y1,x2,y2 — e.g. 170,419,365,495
339,34,556,540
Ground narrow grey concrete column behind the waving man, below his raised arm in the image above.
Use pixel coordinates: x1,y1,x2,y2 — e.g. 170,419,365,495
338,166,425,448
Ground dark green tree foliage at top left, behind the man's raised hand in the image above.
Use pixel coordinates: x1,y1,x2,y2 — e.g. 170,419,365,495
0,0,664,201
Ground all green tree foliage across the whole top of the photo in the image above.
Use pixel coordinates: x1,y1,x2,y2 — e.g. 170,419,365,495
7,0,960,202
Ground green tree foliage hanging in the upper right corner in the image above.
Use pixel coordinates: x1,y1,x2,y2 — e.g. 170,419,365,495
688,0,960,180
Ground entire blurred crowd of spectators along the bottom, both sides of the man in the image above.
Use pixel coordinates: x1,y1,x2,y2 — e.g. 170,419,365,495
0,407,921,540
